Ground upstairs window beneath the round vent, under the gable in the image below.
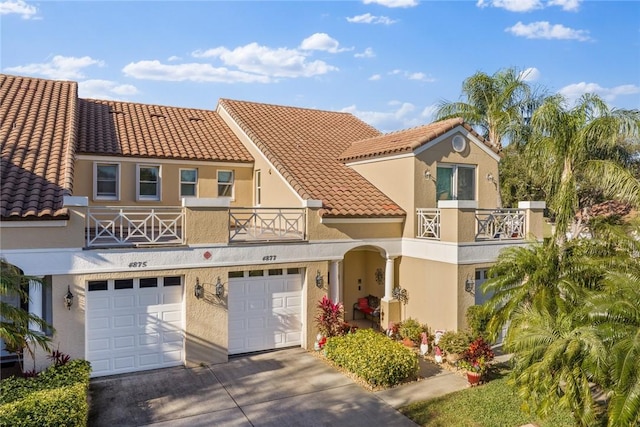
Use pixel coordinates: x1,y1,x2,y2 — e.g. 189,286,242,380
436,164,476,200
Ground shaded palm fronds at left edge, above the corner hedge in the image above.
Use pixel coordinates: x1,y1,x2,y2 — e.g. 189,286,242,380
0,258,53,372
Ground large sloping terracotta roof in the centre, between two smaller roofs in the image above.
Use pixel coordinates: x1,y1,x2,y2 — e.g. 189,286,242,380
219,99,405,217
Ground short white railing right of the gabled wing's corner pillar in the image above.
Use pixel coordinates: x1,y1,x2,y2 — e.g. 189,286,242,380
476,209,525,240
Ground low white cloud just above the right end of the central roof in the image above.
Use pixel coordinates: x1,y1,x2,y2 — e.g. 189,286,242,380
341,101,424,132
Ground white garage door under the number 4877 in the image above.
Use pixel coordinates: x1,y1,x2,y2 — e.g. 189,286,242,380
229,268,302,354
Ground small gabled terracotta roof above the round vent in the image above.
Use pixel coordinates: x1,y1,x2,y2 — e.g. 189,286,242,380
340,118,499,162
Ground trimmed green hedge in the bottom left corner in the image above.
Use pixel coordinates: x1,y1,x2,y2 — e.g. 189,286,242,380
0,360,91,427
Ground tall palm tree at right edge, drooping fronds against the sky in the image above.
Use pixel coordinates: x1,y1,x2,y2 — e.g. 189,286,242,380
526,94,640,242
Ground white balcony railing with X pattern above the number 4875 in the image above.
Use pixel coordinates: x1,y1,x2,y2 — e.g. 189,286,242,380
86,206,185,247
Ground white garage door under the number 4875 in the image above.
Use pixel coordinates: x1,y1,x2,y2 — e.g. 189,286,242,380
85,277,184,376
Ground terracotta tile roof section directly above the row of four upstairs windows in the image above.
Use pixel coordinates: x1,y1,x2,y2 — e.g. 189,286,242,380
77,99,253,162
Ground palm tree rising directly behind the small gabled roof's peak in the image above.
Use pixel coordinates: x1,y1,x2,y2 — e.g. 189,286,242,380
436,68,542,207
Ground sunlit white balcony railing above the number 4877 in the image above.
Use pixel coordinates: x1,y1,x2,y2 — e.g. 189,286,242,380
229,208,307,243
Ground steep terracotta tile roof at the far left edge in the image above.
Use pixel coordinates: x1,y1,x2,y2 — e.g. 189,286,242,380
0,74,78,220
